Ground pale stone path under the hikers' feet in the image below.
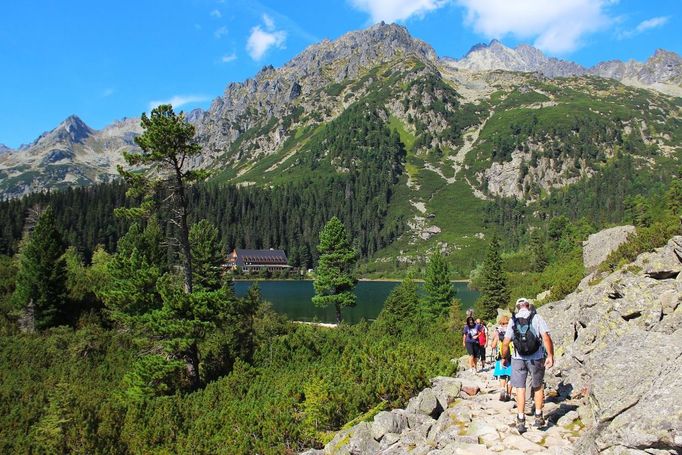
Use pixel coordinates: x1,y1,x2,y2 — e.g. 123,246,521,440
305,360,586,455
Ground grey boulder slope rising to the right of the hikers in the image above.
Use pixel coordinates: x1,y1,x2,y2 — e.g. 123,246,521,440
539,236,682,453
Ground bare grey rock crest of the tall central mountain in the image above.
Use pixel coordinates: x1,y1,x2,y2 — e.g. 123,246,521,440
196,23,437,167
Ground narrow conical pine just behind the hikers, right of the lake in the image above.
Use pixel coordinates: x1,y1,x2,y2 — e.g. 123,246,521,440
476,235,510,320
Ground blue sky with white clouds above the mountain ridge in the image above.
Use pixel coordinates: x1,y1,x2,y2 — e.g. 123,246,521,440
0,0,682,147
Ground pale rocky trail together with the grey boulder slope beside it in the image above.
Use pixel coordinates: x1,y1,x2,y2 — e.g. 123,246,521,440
305,233,682,455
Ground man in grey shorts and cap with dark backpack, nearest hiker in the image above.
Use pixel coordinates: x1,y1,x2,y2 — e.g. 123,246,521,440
502,297,554,433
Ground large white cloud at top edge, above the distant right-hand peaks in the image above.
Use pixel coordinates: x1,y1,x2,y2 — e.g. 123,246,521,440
457,0,617,54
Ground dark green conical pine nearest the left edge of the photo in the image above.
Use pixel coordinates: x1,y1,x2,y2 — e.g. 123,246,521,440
12,207,67,332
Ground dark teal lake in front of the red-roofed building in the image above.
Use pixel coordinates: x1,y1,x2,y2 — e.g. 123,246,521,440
234,280,478,323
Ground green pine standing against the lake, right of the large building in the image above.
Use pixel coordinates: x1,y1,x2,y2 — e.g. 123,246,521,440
313,217,358,323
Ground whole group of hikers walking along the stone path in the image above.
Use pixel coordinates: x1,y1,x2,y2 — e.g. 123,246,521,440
462,297,554,433
